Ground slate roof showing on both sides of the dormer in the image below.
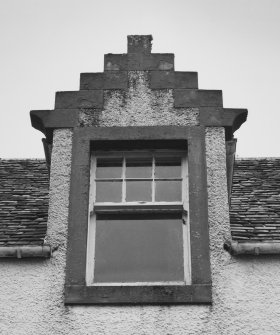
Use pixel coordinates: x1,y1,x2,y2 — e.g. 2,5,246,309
0,158,280,246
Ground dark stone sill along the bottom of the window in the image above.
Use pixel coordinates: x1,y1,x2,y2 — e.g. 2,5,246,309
65,284,212,305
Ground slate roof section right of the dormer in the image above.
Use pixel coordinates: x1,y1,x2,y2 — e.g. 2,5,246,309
230,158,280,242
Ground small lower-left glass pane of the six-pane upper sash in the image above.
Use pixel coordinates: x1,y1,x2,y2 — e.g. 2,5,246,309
96,181,122,202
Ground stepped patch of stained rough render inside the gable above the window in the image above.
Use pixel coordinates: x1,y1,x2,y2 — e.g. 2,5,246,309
77,71,198,127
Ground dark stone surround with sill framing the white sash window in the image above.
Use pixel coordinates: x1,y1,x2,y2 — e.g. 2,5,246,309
65,126,212,304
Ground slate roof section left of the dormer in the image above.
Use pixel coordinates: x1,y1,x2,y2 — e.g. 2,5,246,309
0,159,49,246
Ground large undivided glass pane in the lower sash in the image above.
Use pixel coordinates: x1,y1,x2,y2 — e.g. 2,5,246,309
94,214,184,283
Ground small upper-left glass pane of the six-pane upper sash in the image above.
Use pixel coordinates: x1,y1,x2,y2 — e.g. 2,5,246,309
96,158,122,178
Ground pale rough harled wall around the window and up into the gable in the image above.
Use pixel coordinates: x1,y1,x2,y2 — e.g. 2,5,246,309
0,72,280,335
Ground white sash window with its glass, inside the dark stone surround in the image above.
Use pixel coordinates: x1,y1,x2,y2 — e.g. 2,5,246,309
86,150,190,286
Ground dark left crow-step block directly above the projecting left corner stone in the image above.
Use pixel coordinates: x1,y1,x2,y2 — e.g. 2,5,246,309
55,90,103,108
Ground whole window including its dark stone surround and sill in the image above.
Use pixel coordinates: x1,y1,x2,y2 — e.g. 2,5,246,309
65,126,212,305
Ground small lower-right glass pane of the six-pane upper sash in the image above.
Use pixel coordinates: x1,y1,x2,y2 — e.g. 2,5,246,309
155,180,182,201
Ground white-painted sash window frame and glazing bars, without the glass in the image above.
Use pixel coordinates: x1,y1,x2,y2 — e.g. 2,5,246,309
86,149,191,286
